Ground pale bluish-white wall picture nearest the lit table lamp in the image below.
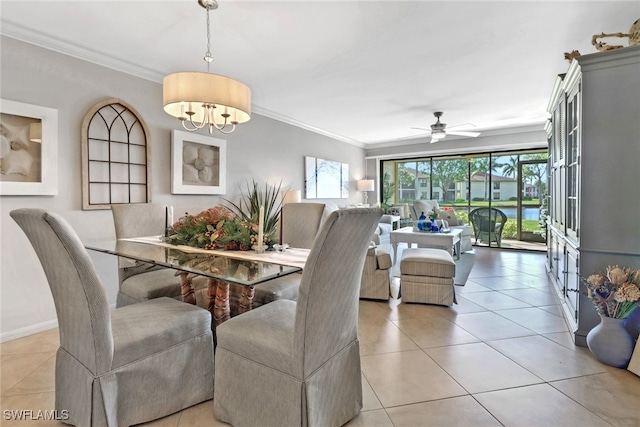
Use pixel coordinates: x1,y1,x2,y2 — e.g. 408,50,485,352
304,156,349,199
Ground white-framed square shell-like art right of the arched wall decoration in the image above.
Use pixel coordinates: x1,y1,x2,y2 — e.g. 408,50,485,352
171,130,227,194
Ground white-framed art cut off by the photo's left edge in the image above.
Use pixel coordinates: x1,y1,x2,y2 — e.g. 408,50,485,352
0,99,58,196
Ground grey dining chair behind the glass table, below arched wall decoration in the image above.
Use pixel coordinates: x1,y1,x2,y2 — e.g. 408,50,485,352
111,203,208,307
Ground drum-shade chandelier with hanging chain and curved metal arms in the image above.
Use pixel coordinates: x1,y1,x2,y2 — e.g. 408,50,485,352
162,0,251,134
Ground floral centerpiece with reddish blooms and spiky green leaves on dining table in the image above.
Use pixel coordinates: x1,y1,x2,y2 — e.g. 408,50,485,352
167,182,281,251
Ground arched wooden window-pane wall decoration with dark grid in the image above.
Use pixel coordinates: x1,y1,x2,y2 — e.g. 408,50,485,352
82,99,151,210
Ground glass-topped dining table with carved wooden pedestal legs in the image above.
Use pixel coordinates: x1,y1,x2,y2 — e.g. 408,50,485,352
83,236,309,326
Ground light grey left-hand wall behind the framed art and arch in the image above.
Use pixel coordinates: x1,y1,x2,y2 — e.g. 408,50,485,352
0,37,365,341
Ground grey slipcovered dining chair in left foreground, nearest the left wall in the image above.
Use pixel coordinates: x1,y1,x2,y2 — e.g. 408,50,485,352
11,209,214,427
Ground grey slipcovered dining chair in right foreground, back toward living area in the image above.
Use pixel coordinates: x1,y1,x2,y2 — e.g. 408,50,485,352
214,208,382,426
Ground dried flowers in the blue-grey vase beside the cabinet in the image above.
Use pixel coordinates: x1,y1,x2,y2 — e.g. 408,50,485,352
586,265,640,319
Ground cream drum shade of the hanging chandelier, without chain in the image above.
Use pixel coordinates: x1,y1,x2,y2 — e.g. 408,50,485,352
162,72,251,125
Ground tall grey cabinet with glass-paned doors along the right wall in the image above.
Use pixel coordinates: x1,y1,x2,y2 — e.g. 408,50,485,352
546,46,640,345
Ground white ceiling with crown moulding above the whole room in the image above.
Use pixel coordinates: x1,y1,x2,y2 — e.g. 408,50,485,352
0,0,640,147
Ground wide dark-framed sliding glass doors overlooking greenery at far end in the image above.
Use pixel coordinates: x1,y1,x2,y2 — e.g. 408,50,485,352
381,150,548,251
